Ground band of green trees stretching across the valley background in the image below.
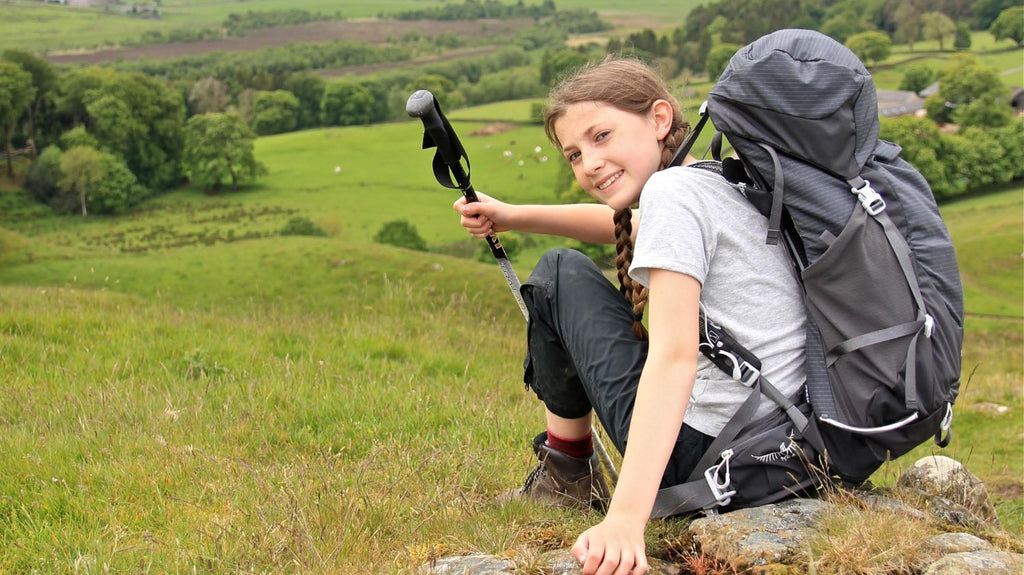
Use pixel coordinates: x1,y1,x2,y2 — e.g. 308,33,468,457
0,0,1024,215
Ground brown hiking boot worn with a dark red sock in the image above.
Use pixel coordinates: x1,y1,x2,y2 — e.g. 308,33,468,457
501,432,610,512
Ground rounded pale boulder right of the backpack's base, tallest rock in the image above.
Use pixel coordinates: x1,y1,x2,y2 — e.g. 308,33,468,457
897,455,998,525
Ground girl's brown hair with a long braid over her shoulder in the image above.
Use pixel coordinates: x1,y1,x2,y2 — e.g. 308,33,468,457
544,57,690,340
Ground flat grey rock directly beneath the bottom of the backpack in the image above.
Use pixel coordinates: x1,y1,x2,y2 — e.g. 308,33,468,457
689,499,827,571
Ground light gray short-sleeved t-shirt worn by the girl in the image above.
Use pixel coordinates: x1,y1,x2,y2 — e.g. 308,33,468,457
630,167,807,436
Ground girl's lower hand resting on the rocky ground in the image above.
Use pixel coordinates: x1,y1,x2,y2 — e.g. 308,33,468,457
572,515,647,575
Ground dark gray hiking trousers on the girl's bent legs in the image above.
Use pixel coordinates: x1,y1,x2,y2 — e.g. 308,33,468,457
522,249,714,487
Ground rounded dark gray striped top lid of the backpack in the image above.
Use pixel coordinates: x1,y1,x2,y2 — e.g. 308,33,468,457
708,30,879,179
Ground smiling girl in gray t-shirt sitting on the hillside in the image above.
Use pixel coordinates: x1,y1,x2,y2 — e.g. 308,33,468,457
455,59,806,574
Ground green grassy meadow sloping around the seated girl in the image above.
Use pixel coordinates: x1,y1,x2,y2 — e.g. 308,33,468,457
0,91,1024,573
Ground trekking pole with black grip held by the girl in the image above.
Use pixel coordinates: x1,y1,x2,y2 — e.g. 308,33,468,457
406,90,618,481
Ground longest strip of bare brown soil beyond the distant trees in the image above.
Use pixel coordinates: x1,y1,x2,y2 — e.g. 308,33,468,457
47,18,534,64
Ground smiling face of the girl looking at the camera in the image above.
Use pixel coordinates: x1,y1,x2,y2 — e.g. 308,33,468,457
554,100,672,210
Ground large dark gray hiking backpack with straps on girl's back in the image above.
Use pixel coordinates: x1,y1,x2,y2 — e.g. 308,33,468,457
652,30,964,517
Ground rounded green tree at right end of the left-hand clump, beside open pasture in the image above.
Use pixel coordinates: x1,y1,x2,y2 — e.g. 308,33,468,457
182,113,266,191
